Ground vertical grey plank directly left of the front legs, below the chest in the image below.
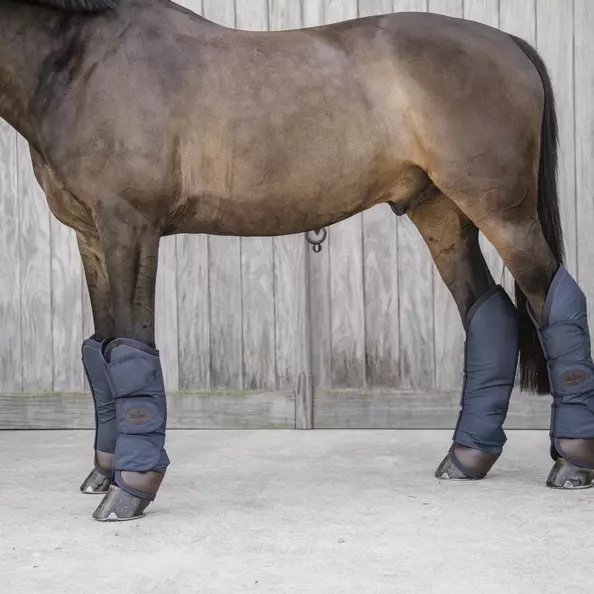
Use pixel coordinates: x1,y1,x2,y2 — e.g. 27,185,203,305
50,220,84,392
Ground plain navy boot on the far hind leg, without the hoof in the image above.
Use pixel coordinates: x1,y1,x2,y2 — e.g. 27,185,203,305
454,286,519,455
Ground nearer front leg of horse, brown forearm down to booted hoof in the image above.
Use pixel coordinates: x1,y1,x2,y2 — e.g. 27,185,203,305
93,212,169,521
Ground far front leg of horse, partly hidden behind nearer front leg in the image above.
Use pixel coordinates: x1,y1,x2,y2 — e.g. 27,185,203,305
78,229,117,494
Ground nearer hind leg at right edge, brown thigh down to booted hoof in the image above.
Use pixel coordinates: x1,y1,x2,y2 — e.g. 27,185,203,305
460,188,594,488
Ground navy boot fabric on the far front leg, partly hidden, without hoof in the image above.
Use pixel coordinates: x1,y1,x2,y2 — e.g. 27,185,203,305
81,338,118,454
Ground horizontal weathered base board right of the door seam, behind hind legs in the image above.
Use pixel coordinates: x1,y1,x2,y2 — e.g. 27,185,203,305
314,390,551,429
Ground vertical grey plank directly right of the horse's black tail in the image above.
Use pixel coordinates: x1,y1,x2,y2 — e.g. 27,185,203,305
536,0,572,274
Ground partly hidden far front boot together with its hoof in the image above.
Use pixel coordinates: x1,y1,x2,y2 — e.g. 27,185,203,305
80,337,118,495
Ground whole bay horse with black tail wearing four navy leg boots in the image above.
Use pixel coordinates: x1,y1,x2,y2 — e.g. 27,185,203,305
0,0,594,521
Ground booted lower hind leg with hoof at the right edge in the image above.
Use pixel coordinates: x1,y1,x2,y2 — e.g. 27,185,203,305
529,266,594,489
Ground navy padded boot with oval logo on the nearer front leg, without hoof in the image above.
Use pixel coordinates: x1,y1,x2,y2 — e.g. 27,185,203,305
102,338,169,476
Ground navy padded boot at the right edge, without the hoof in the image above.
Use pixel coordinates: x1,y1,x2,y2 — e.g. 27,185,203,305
533,266,594,439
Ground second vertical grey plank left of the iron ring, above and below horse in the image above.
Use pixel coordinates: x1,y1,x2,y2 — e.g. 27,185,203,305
236,0,276,390
